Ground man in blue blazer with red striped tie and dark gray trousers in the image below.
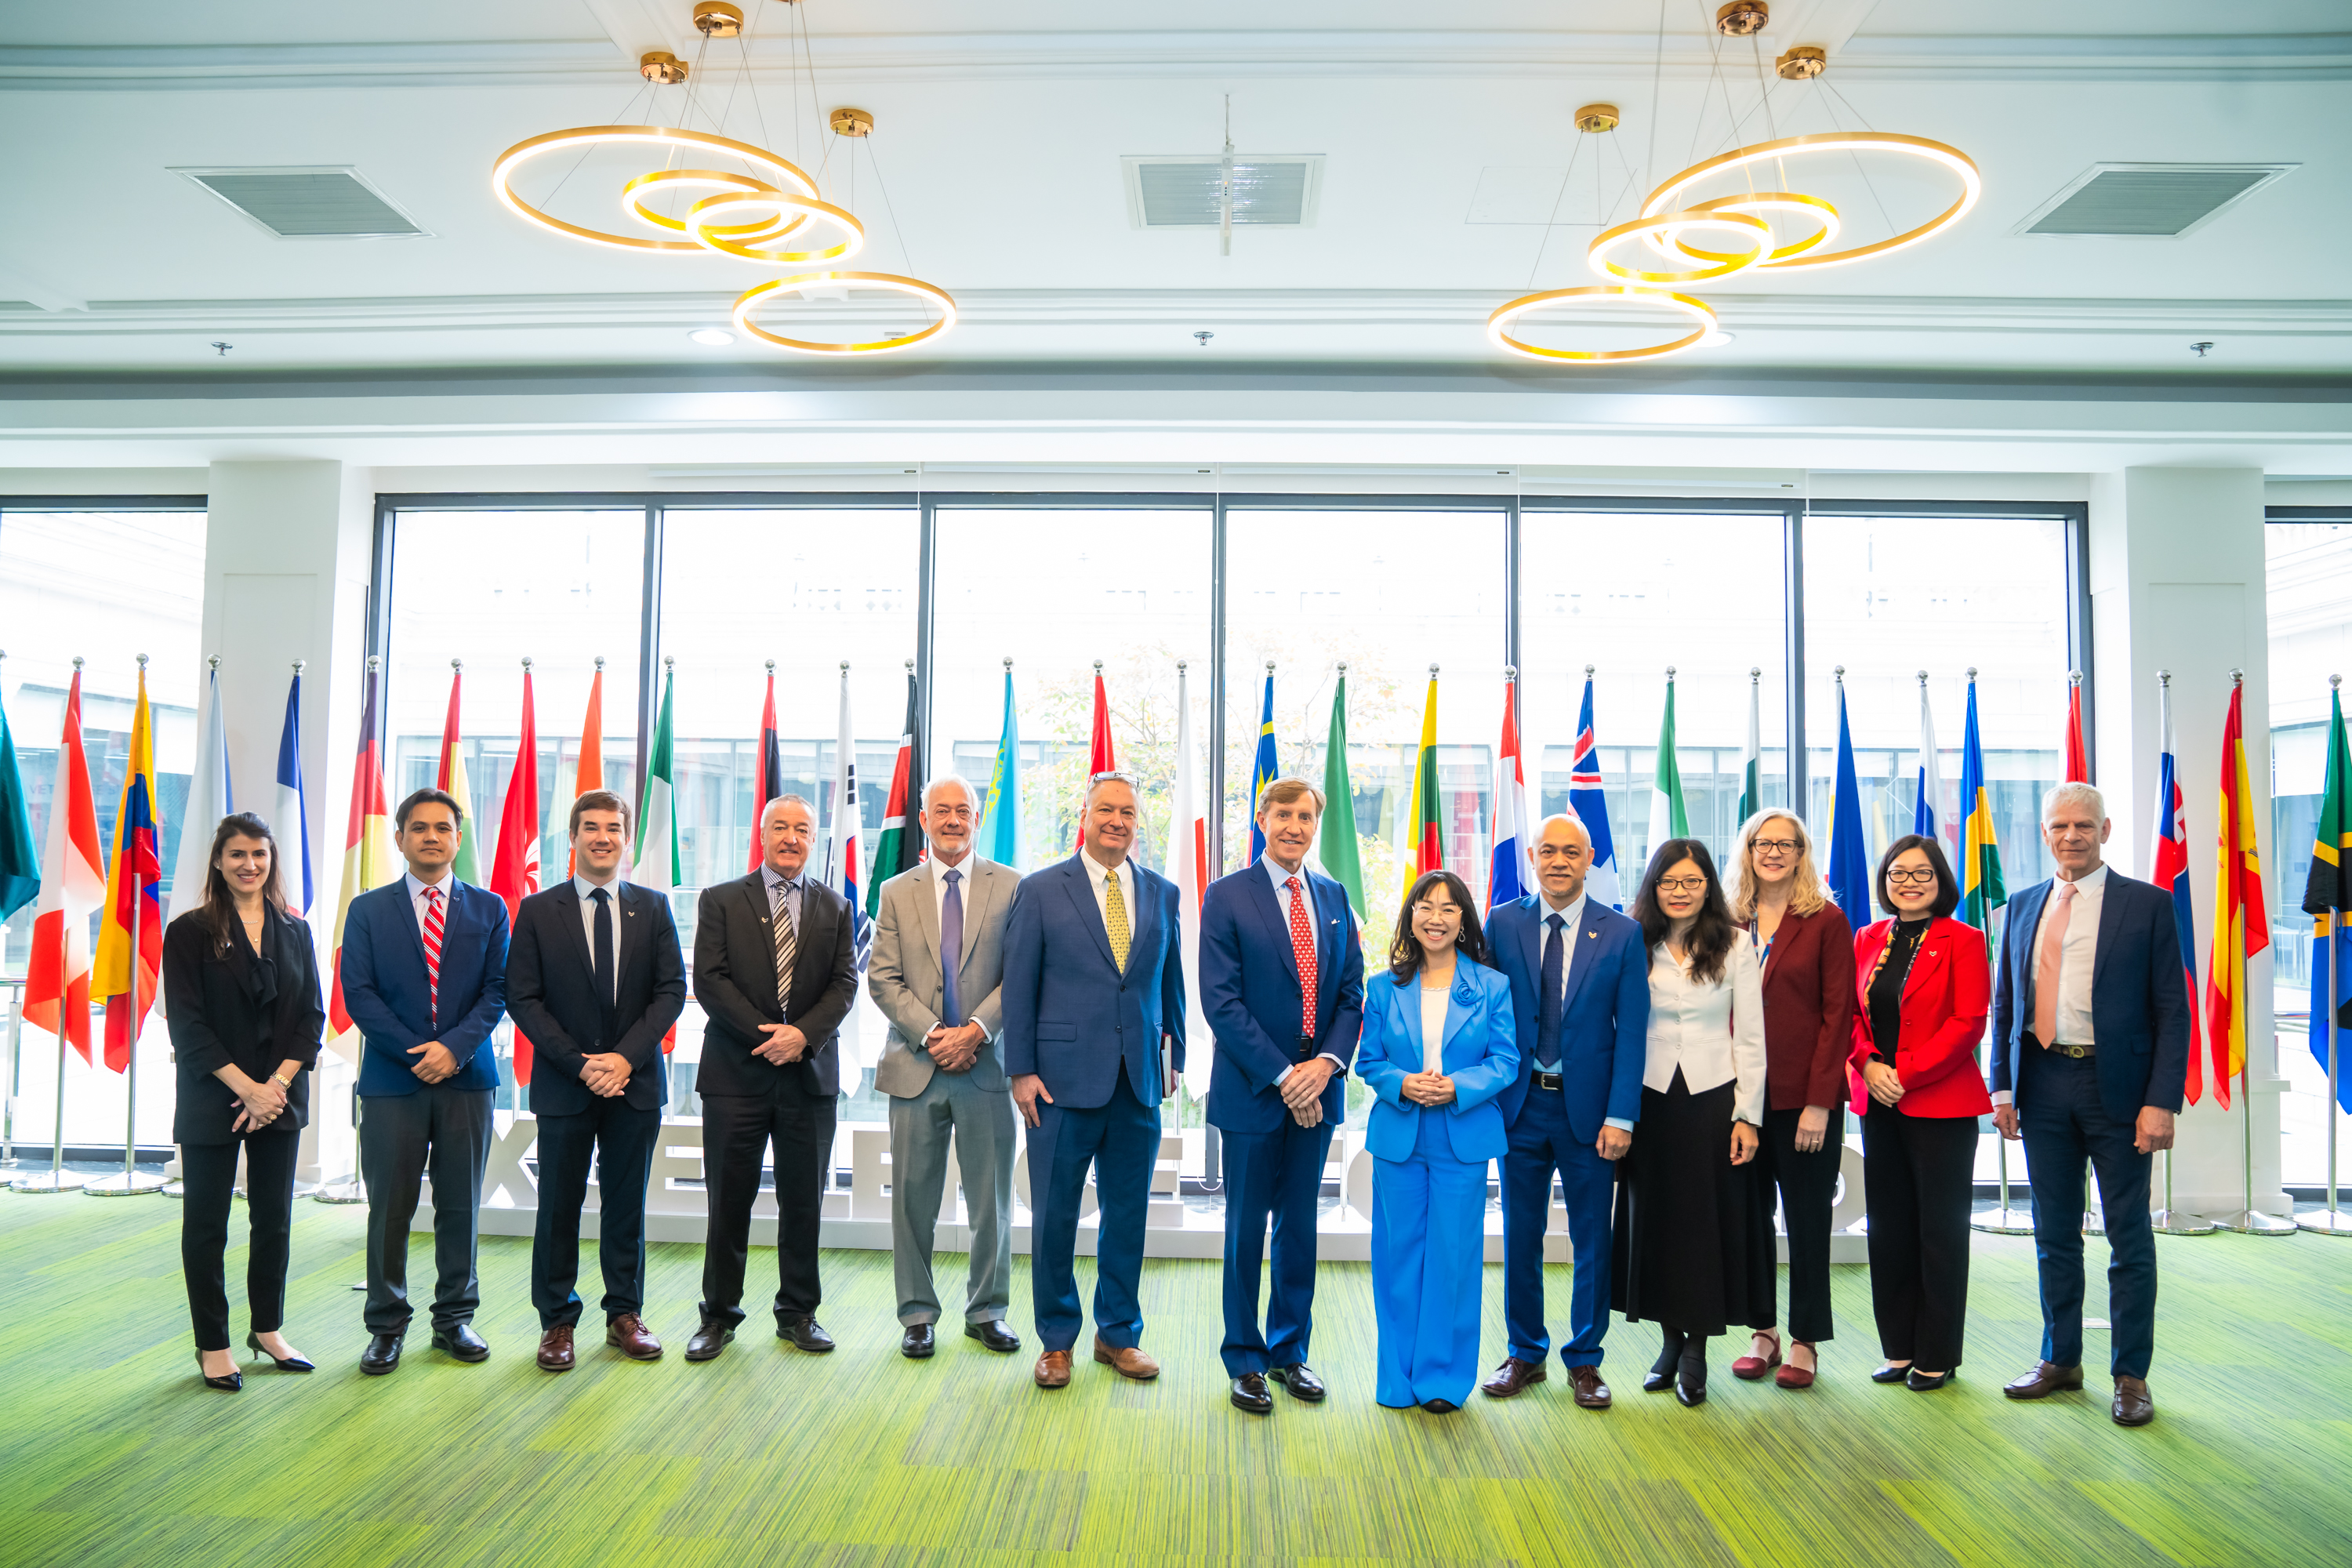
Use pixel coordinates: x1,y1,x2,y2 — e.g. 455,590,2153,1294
339,789,506,1375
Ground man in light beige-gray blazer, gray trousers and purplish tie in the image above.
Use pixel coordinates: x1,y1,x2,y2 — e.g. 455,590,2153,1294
866,774,1021,1361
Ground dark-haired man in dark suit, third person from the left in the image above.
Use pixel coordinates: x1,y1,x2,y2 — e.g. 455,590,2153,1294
506,789,687,1373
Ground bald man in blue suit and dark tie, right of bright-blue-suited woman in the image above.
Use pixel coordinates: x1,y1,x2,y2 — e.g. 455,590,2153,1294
1479,815,1649,1410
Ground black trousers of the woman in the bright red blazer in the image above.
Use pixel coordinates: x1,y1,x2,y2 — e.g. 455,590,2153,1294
1863,1100,1976,1373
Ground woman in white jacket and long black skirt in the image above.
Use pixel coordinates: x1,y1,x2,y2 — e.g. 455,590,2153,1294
1609,839,1773,1406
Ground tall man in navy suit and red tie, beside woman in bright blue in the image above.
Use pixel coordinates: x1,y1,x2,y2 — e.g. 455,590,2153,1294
1200,779,1364,1415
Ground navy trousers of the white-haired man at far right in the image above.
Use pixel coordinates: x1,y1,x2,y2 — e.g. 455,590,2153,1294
2018,1044,2157,1377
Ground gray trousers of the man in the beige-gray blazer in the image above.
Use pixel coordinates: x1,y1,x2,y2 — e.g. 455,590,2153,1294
889,1072,1014,1326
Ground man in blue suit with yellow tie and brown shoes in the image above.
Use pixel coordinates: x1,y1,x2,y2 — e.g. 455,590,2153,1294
1002,774,1183,1389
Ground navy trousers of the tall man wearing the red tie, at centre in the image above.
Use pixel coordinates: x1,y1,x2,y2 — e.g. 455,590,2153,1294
1221,1112,1331,1377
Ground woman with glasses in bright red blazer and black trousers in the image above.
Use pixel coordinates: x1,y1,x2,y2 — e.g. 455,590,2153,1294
1851,832,1992,1394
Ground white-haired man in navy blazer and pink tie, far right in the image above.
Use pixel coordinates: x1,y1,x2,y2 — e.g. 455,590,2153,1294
1992,783,2190,1427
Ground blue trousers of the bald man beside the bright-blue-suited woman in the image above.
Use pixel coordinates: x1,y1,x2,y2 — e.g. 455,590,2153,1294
1503,1083,1616,1366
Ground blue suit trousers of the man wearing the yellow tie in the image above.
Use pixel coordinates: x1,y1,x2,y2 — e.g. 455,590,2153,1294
1028,1067,1160,1349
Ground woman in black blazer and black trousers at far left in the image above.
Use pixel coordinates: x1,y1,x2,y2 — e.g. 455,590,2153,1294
162,811,327,1392
